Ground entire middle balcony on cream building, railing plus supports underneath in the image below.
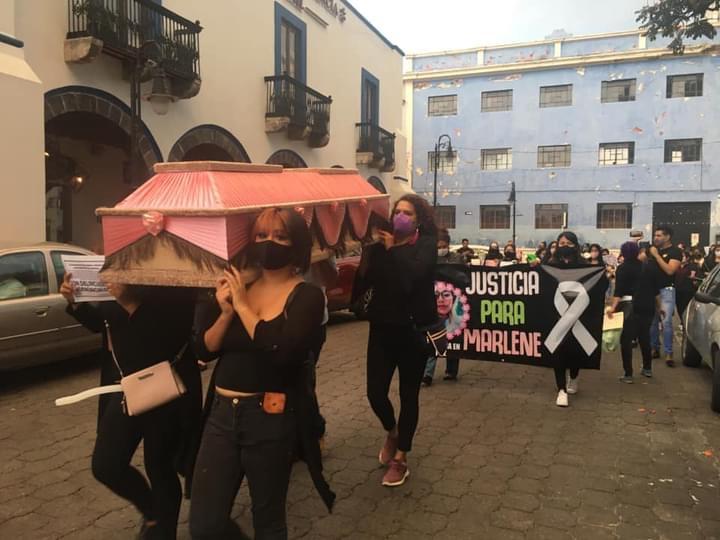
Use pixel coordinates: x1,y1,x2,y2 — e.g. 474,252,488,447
265,75,332,148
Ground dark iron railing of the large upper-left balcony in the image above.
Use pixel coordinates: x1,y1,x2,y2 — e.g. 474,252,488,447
67,0,202,78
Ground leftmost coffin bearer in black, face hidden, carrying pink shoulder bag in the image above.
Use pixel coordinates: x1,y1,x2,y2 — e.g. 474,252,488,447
60,272,202,539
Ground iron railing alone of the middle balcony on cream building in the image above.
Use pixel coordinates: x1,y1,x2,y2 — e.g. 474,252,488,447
265,75,332,133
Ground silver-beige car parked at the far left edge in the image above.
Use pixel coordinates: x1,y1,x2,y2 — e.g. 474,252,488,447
0,242,101,371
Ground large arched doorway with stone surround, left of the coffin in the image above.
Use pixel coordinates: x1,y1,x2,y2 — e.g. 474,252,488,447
45,86,162,251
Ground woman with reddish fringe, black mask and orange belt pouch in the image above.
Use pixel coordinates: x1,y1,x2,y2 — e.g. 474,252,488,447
190,209,334,539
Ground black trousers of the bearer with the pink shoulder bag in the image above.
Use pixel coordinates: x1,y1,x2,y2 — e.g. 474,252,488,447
92,394,184,539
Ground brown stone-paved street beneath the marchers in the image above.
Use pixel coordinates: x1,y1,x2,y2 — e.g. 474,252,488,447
0,315,720,540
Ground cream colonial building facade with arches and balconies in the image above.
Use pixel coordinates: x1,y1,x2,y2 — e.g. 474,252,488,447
0,0,410,250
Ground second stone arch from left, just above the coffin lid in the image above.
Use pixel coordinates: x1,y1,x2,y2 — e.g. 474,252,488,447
168,124,250,163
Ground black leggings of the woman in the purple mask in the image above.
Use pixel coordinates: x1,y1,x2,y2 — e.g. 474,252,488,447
367,323,428,452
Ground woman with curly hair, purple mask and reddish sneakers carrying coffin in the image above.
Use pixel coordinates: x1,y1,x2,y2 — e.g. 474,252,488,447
356,195,438,486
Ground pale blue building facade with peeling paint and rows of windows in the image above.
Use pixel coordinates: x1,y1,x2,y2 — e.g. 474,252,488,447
405,28,720,247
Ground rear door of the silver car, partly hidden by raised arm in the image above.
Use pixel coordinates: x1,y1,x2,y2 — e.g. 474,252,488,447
50,250,101,356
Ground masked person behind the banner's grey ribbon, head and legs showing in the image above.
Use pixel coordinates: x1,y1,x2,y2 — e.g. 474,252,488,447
547,231,587,407
